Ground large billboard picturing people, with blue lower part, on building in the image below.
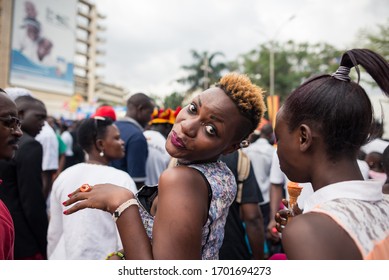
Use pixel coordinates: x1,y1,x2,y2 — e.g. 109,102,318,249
9,0,77,95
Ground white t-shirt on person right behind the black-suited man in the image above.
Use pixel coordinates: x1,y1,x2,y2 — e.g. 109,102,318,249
35,121,59,171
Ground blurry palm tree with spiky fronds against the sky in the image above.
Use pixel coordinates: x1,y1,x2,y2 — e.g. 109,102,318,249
177,50,227,93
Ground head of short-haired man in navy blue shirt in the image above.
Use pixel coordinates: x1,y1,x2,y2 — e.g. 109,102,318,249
126,93,154,127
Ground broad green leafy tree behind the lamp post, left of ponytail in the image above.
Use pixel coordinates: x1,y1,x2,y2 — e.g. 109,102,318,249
236,41,341,100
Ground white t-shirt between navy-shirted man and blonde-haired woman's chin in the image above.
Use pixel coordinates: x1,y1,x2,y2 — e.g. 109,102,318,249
143,130,170,186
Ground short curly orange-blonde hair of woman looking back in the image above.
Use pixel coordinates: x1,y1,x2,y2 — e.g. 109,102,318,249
215,73,266,131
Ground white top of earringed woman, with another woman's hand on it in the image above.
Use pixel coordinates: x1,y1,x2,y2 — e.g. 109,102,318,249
47,163,137,260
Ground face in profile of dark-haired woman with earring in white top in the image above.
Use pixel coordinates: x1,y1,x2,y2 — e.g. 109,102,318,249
102,124,124,160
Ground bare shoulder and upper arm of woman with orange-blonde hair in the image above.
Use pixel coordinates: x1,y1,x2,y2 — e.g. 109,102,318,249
153,166,208,259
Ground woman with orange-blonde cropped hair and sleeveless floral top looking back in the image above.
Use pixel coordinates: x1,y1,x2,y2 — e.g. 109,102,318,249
64,73,265,259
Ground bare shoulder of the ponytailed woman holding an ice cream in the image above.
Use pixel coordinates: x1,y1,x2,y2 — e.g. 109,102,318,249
282,212,361,260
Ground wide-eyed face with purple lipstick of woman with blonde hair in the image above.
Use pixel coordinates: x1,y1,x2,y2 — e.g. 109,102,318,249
166,88,248,163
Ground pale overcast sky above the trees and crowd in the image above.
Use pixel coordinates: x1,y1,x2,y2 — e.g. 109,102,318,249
94,0,389,96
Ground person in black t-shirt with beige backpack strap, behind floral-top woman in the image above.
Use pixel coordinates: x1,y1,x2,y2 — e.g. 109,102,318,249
219,151,264,260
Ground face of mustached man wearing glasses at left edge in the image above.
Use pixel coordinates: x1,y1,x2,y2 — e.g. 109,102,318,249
0,93,23,160
